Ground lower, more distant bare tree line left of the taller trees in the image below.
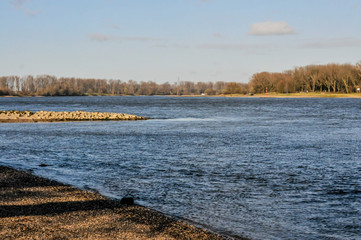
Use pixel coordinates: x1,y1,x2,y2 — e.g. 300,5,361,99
0,75,247,96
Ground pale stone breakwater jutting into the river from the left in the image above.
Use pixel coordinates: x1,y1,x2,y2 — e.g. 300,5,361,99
0,111,147,122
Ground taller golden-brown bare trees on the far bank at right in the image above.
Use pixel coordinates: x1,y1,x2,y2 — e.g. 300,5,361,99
249,61,361,93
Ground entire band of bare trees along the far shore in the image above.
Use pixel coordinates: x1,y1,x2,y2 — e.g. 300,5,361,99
0,61,361,96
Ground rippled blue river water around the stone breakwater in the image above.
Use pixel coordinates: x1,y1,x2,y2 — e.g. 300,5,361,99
0,97,361,240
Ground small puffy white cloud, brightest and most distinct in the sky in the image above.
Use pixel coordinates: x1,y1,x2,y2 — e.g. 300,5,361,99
248,21,296,36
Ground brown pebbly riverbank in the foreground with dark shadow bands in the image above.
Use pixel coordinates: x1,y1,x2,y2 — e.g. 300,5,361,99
0,166,240,240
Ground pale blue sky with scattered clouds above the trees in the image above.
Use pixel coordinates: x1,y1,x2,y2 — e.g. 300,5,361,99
0,0,361,83
